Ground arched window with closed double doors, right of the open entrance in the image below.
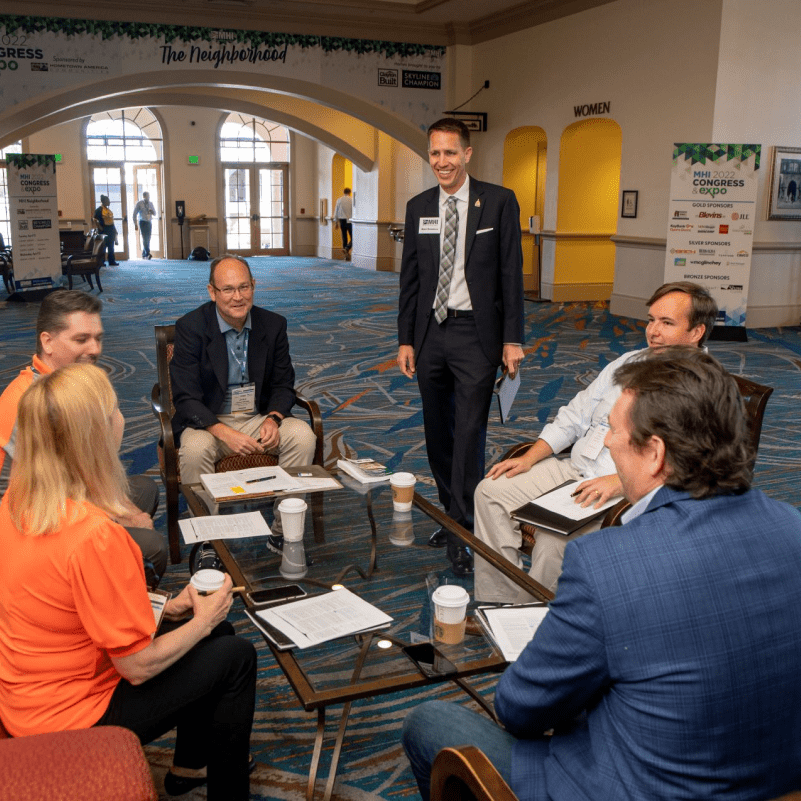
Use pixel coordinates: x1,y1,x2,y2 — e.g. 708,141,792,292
220,113,290,255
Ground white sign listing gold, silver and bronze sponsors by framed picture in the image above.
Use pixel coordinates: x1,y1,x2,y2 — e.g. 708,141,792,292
665,143,762,326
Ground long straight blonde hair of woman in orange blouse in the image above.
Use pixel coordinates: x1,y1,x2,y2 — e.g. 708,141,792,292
8,364,128,537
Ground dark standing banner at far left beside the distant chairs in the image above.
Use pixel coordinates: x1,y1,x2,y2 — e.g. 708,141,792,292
6,153,61,292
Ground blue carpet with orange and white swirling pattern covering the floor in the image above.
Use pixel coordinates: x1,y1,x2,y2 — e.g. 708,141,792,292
0,258,801,801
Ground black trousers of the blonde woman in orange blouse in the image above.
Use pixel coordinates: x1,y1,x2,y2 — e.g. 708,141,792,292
95,621,256,801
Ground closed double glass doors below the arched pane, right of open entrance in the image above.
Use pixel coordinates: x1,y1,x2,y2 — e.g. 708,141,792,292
223,164,289,256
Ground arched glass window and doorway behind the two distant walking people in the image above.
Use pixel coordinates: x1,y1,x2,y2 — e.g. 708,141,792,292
86,108,164,258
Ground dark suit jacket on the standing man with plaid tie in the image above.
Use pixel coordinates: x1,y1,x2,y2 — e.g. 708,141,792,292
398,178,523,364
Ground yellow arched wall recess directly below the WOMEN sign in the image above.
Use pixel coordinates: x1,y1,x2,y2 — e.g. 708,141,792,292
552,119,623,300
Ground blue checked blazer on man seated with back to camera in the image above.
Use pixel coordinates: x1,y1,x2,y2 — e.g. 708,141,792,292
495,487,801,801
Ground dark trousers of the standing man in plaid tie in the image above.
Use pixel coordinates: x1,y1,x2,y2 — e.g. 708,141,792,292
415,312,498,539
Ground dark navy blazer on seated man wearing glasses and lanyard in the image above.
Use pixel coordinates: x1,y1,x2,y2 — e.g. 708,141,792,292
170,301,295,435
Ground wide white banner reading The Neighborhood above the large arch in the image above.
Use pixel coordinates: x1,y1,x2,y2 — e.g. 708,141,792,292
0,14,447,133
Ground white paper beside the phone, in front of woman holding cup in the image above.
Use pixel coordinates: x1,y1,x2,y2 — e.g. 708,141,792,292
256,588,392,648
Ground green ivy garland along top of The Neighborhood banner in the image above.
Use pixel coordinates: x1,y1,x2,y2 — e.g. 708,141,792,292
0,14,445,58
